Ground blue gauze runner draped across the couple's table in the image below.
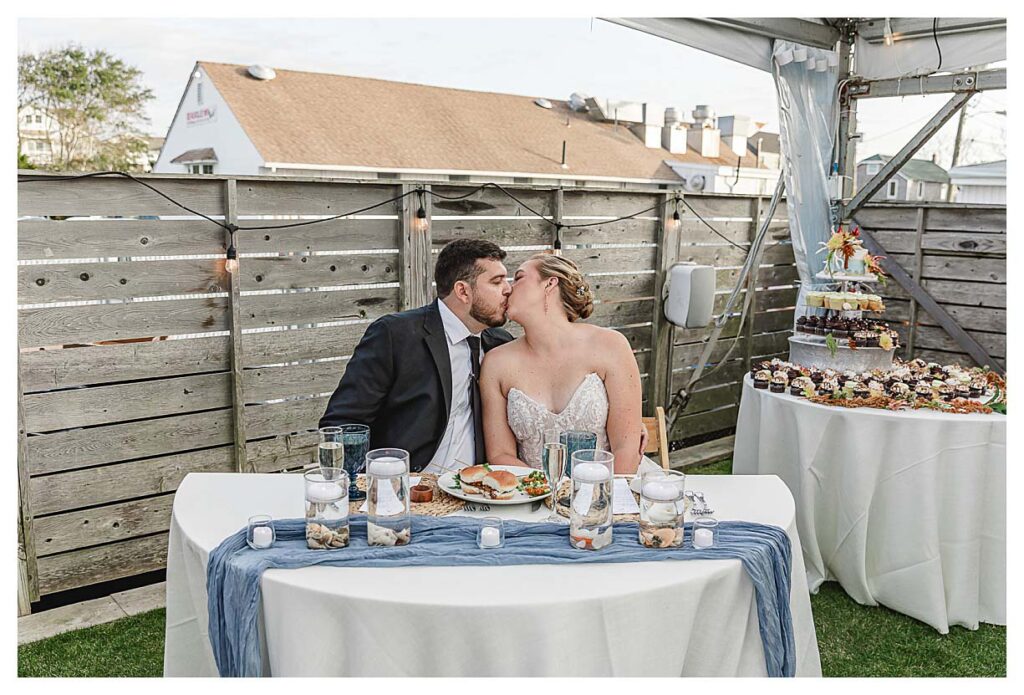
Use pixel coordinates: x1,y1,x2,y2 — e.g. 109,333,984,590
206,515,796,677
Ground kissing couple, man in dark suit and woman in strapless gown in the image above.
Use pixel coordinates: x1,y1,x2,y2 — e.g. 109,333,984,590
319,240,644,474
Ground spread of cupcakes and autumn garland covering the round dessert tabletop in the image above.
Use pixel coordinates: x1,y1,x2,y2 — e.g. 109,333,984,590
751,358,1007,415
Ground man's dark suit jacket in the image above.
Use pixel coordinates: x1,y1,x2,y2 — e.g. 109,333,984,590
319,300,512,471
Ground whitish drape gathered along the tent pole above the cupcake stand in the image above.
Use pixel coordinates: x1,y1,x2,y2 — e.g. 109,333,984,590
773,41,839,315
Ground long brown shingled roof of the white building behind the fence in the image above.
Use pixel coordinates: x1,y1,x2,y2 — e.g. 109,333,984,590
199,61,770,181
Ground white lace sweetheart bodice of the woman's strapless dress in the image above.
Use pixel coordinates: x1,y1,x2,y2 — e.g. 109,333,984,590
508,372,608,468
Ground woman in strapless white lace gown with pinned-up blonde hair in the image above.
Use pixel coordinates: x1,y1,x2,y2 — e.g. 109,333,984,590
480,254,643,473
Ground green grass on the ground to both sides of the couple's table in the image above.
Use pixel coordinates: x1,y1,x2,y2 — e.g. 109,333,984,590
17,461,1007,677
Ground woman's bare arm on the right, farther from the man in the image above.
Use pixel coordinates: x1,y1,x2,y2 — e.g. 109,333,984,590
604,331,643,473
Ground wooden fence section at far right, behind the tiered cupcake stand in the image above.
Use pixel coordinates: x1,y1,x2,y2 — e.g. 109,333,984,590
857,203,1007,366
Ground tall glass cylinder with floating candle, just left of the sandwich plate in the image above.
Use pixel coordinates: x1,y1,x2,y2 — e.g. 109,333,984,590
367,448,405,546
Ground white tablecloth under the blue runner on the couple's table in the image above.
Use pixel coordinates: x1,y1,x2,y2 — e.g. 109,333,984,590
164,473,821,676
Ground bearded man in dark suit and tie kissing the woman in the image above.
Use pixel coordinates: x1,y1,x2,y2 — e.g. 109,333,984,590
319,240,512,473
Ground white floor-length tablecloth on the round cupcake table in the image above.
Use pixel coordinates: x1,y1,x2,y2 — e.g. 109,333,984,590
732,376,1007,634
